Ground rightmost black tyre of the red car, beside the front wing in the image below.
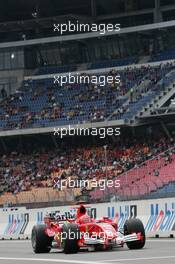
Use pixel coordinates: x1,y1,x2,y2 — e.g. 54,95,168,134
124,219,146,249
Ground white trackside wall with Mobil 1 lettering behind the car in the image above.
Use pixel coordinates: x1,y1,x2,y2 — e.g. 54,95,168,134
0,198,175,239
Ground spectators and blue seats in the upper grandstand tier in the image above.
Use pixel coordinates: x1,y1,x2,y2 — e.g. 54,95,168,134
0,63,174,130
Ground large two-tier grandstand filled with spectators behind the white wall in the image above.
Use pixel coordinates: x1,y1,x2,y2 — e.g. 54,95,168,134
0,0,175,207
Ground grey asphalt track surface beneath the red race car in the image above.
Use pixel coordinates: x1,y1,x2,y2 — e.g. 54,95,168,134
0,239,175,264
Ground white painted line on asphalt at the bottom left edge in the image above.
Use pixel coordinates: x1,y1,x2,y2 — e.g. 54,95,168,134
0,257,110,264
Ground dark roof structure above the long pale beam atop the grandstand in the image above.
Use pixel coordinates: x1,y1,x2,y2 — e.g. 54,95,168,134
0,0,175,42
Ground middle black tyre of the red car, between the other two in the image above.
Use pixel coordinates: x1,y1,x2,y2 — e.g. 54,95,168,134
61,223,80,254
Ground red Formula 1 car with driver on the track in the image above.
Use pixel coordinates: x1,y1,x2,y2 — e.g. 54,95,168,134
31,205,146,254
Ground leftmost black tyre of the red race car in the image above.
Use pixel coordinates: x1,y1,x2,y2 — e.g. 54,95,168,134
31,225,53,254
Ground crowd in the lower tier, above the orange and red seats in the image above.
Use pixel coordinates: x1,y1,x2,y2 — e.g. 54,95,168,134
0,137,174,194
